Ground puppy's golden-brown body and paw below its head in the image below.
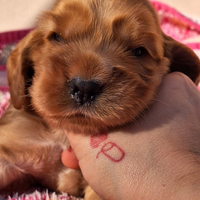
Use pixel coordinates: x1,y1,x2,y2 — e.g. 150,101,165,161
0,105,86,195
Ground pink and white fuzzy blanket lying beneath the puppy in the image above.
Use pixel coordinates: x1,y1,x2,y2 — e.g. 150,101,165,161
0,1,200,200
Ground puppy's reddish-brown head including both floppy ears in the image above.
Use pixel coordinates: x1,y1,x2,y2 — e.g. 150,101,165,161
7,0,200,134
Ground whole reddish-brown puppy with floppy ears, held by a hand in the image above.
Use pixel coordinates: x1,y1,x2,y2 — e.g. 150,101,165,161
0,0,200,200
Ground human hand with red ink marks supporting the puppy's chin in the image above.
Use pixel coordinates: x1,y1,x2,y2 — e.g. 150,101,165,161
62,72,200,200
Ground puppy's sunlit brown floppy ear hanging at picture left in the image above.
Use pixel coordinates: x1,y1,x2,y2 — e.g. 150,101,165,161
7,31,36,109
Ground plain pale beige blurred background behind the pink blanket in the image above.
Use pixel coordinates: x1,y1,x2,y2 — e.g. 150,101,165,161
0,0,200,32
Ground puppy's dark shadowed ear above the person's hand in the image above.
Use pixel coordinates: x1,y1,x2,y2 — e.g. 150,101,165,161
164,35,200,84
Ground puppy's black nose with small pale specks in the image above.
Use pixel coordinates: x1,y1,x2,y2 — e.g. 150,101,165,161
69,78,101,105
